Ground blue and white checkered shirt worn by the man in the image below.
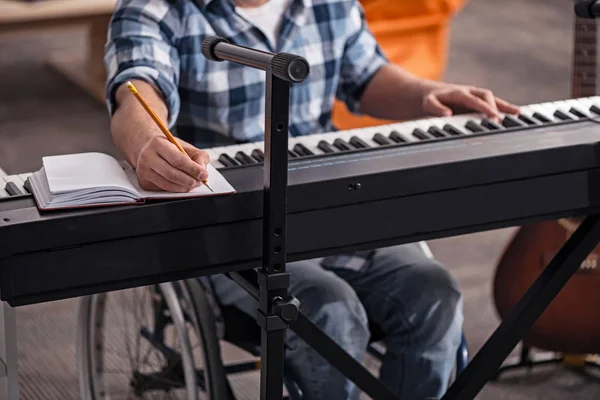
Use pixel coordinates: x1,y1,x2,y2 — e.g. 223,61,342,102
105,0,387,268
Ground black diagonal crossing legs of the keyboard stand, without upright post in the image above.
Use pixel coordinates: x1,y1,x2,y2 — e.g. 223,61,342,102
231,215,600,400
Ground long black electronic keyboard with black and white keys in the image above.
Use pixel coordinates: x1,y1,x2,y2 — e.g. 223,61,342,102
0,97,600,306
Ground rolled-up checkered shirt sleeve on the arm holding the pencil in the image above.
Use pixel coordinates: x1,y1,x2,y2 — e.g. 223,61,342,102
104,0,181,127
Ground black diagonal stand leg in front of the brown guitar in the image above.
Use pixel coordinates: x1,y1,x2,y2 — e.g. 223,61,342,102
442,215,600,400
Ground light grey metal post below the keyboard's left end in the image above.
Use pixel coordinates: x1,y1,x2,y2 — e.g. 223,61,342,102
0,301,19,400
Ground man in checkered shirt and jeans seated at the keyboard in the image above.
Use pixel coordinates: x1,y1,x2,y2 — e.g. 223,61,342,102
105,0,518,400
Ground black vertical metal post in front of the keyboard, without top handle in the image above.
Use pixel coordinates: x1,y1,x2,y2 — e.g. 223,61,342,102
257,71,290,400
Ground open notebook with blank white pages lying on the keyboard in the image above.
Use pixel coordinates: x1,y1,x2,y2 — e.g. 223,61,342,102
29,153,235,210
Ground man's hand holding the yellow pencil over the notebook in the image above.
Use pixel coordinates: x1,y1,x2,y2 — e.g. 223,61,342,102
136,136,209,192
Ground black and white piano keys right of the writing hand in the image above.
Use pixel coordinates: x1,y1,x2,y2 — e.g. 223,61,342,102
205,96,600,168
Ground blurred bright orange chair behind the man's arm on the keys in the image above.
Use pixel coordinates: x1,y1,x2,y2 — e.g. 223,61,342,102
333,0,467,129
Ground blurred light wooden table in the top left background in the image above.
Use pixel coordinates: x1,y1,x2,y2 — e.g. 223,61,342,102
0,0,116,103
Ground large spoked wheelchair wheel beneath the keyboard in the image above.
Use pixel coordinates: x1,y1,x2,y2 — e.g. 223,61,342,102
77,280,226,400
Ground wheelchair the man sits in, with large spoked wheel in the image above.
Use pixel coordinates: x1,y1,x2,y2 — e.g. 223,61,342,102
76,242,469,400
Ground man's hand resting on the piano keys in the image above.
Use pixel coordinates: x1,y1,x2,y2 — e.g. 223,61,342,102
423,84,519,121
